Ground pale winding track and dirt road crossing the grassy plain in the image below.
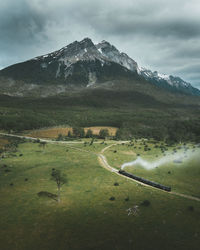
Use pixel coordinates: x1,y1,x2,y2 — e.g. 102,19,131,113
0,133,200,201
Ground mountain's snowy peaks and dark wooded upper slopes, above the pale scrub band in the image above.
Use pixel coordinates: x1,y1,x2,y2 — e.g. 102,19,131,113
0,37,200,95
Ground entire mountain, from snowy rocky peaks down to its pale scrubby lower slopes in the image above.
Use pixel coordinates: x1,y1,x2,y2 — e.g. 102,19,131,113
0,38,200,96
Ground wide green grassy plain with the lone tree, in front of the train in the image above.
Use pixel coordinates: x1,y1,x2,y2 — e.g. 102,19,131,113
0,138,200,250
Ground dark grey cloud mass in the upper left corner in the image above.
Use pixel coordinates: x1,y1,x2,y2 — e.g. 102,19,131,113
0,0,49,66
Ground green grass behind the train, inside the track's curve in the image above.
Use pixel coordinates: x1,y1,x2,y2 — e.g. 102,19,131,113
105,141,200,197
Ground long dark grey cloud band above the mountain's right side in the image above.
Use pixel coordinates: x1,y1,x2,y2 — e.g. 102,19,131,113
89,10,200,39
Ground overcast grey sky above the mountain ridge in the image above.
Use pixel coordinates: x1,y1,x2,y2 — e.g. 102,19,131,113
0,0,200,88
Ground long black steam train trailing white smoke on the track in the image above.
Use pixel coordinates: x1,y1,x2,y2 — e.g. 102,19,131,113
118,169,171,192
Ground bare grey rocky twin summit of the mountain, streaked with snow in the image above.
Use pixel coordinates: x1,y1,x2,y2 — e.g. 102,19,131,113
34,38,138,77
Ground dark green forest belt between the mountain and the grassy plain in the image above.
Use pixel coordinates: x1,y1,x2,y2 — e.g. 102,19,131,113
0,87,200,143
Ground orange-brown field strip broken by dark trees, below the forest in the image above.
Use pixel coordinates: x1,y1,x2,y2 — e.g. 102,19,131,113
27,126,117,139
